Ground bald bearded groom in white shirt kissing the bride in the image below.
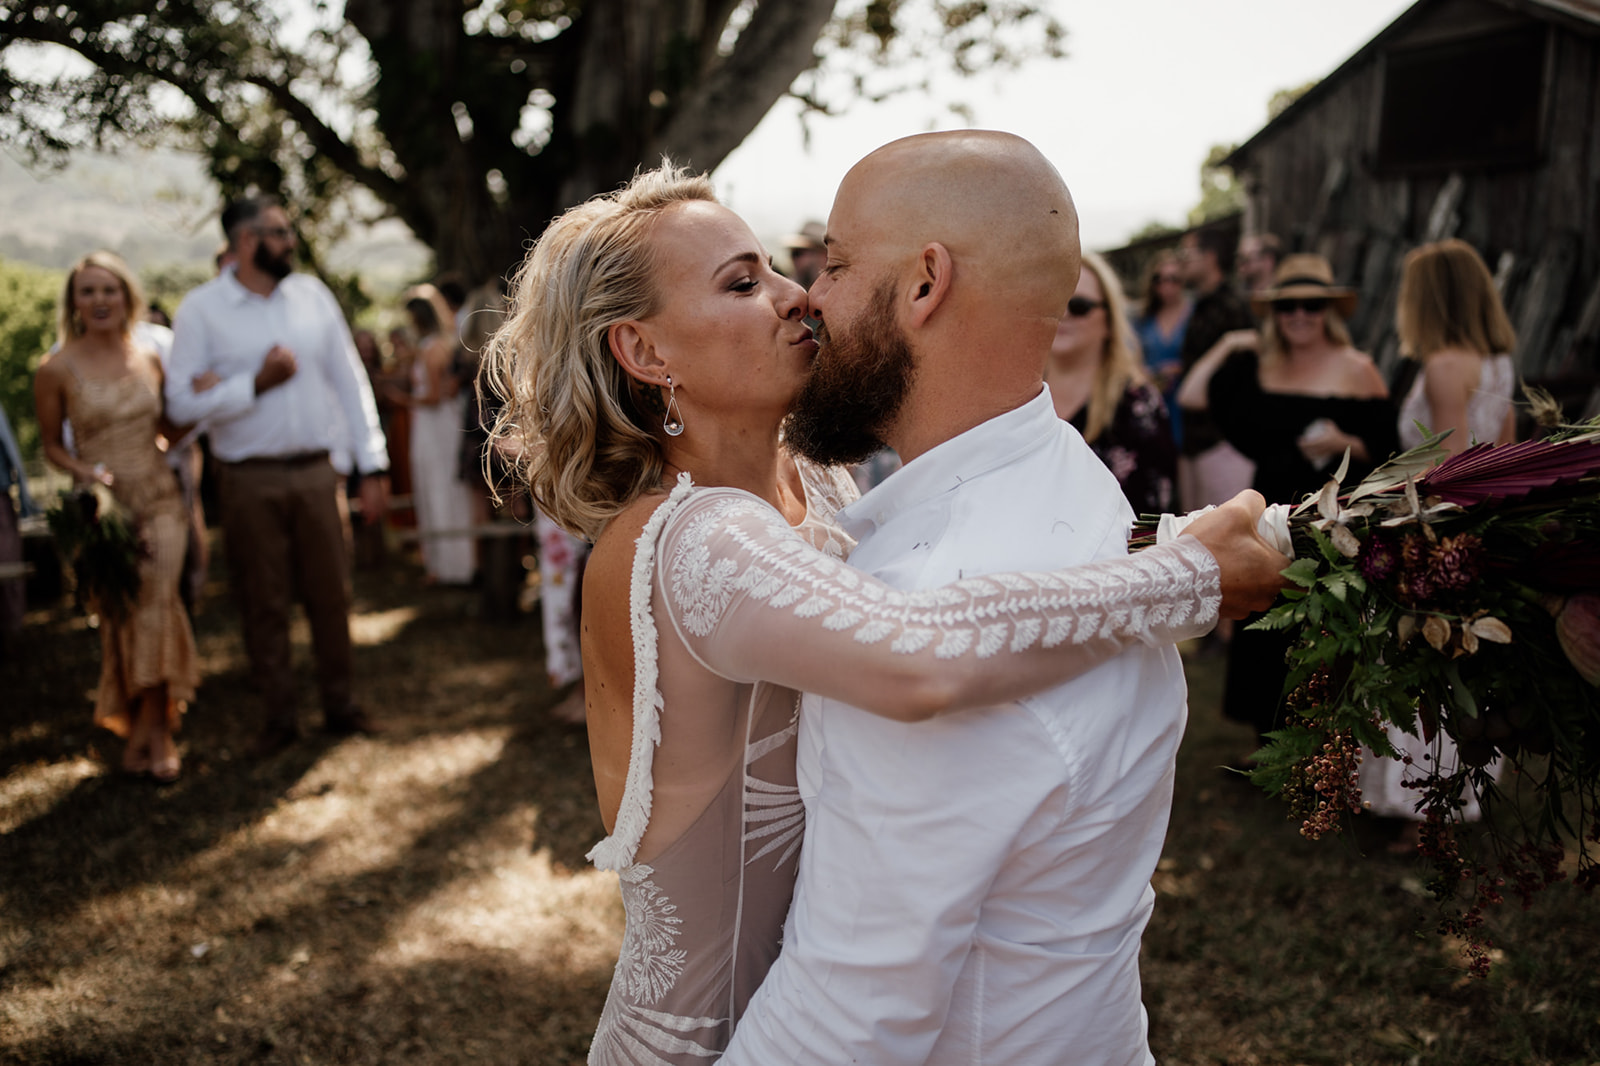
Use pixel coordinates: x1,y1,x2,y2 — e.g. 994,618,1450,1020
722,131,1288,1066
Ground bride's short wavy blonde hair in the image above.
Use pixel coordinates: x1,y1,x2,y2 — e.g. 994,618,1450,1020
478,158,717,541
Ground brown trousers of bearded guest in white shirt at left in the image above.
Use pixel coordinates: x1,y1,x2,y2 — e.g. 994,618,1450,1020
221,456,350,727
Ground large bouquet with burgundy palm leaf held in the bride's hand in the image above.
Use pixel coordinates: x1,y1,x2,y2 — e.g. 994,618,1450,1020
1134,419,1600,973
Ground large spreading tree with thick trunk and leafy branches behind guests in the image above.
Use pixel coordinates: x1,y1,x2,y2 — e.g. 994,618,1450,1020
0,0,1066,281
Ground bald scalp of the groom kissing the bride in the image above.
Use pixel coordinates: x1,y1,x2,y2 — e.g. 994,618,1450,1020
829,130,1080,323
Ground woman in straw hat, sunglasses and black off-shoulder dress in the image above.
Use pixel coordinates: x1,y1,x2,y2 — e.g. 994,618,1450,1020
1178,254,1398,745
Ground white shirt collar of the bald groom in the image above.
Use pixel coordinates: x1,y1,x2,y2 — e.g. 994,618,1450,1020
837,384,1061,541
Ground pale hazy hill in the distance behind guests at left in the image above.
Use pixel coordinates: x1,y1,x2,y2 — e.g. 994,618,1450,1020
0,150,430,290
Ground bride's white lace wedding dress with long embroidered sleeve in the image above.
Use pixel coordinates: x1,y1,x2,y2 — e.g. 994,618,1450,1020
589,451,1221,1066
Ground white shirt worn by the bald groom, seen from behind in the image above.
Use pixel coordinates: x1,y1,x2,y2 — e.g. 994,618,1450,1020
722,391,1187,1066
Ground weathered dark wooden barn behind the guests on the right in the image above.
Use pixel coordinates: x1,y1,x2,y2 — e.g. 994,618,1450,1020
1227,0,1600,416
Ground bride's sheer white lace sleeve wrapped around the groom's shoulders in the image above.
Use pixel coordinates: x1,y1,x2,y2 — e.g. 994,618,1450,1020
656,476,1221,720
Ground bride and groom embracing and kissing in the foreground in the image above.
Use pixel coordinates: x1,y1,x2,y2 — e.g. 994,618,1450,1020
486,131,1288,1066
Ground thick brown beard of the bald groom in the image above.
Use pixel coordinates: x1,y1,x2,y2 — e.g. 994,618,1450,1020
784,280,917,466
